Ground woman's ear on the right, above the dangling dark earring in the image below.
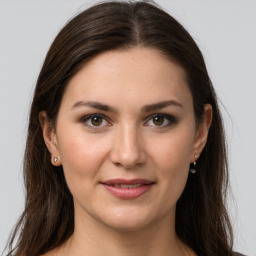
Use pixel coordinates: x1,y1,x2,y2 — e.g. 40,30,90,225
190,104,212,163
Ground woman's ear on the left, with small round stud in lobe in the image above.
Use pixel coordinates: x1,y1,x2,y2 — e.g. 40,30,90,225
38,111,61,166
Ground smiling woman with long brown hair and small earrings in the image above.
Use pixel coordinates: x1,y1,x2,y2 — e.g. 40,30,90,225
3,2,244,256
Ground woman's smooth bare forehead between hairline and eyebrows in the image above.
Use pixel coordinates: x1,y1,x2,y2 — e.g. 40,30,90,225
60,47,192,110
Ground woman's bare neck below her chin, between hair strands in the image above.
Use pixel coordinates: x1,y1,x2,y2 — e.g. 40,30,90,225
62,207,188,256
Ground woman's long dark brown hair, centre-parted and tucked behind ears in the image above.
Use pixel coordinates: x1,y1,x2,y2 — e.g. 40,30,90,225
4,1,232,256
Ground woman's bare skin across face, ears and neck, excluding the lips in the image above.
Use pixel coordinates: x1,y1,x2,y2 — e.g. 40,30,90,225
39,47,212,256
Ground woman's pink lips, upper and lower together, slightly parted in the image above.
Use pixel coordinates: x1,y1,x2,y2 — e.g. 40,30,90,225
101,179,155,200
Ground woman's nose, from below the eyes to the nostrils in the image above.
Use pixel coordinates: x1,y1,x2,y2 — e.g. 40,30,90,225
110,123,146,169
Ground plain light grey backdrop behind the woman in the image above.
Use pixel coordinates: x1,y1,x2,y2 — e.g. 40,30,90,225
0,0,256,256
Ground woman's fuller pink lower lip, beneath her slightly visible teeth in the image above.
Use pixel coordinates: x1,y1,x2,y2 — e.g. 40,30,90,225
103,183,153,199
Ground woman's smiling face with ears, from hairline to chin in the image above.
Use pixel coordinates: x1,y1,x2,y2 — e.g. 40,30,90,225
41,48,210,230
